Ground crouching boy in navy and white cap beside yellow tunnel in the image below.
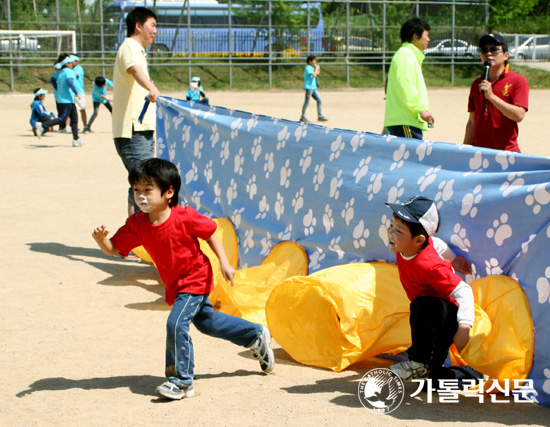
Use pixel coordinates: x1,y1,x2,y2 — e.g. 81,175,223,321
386,196,479,381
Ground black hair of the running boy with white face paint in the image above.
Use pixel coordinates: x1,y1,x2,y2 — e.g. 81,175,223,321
128,158,181,206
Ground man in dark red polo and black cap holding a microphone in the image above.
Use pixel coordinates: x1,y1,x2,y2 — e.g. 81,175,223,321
464,34,529,153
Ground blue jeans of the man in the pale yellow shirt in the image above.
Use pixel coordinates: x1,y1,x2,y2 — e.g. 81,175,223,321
115,130,155,208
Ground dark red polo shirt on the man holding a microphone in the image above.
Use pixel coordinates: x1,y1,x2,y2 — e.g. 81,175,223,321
468,66,529,153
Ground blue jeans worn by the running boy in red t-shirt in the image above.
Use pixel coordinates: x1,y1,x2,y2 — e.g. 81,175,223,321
166,294,262,387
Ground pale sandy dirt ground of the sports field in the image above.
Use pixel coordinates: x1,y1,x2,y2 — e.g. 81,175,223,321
0,88,550,426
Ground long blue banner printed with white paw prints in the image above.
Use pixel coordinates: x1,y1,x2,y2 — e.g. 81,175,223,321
157,97,550,405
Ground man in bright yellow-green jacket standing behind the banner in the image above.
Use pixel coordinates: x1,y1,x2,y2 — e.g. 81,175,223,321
384,18,435,139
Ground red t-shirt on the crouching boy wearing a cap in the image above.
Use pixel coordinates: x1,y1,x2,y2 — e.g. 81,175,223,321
397,237,462,306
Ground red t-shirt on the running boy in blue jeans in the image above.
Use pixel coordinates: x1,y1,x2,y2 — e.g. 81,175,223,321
111,206,217,305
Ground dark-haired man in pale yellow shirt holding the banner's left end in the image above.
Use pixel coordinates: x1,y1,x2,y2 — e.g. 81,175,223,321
112,7,160,215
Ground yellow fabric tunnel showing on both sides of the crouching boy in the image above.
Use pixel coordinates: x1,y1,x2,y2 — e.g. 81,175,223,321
266,262,534,379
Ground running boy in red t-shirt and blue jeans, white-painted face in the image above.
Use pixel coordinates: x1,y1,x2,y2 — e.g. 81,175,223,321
92,158,275,400
